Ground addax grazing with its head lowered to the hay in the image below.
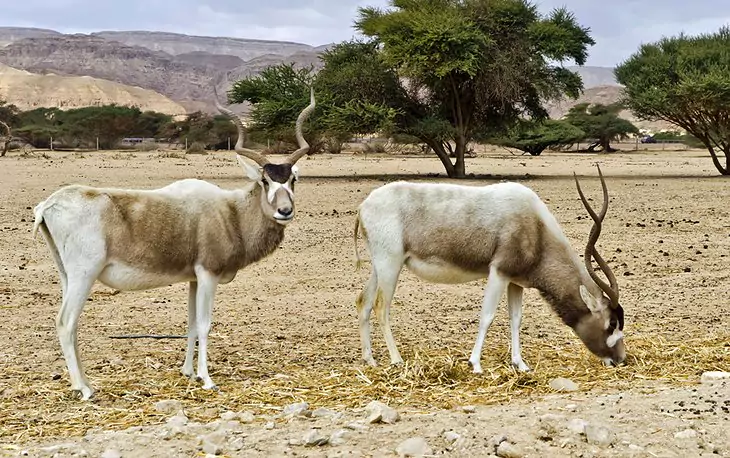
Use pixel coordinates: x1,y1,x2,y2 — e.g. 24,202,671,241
354,167,626,373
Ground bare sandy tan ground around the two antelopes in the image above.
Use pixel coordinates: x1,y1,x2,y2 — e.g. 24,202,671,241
0,151,730,457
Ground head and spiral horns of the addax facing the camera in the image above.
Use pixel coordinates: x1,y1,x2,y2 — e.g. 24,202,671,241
210,89,315,225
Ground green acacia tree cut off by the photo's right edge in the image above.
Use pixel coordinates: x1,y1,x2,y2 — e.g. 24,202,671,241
614,27,730,176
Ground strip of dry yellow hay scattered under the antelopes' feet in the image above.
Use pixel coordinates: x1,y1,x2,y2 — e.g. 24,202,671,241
0,331,730,443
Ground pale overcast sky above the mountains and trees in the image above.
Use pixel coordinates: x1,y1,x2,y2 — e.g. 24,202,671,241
0,0,730,66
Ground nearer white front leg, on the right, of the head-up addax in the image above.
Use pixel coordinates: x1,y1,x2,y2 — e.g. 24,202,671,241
195,267,218,390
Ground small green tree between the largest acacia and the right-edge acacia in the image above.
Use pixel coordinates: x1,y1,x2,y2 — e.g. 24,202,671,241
565,103,639,152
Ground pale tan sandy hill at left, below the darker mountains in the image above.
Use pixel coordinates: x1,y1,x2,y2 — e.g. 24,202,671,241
0,64,185,116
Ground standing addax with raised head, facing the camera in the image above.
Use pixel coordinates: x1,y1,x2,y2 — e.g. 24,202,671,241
33,91,315,400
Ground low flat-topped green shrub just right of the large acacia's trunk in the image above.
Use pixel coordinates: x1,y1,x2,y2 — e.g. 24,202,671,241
492,119,585,156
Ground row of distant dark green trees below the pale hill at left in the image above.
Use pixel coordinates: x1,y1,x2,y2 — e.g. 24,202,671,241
0,101,237,149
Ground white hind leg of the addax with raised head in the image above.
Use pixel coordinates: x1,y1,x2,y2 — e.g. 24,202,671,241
56,271,96,400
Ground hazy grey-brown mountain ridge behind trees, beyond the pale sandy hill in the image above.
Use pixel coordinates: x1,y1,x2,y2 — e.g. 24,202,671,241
0,27,668,130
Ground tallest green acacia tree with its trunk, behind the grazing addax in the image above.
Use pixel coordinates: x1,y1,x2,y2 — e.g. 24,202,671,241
355,0,594,178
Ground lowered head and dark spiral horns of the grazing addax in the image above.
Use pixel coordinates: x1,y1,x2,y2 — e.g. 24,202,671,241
573,166,626,366
